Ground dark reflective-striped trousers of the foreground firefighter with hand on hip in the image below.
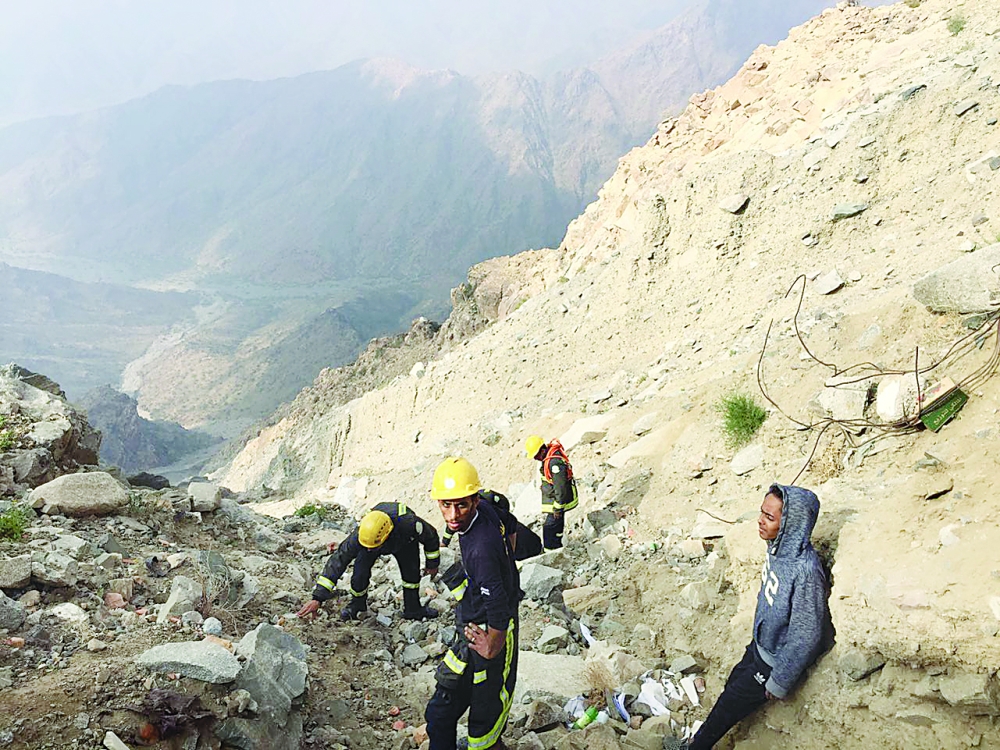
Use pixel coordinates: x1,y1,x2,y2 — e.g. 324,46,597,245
424,620,518,750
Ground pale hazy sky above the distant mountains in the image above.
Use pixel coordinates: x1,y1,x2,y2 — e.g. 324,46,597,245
0,0,695,122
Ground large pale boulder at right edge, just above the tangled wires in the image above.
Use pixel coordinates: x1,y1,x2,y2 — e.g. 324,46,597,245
913,245,1000,313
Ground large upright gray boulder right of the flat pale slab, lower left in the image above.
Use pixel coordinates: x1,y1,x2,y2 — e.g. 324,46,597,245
236,624,309,726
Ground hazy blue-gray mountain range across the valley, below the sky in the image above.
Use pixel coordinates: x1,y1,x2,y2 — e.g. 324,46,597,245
0,0,828,434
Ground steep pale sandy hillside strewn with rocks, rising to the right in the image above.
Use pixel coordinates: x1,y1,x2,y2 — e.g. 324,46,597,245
217,0,1000,748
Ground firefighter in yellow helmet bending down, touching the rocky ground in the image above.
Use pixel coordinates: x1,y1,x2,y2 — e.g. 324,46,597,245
298,503,441,620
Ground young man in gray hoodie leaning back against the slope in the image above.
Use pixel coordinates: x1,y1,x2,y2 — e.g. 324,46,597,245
687,484,833,750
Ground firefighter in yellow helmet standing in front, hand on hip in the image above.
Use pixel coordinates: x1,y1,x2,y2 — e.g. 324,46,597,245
425,458,521,750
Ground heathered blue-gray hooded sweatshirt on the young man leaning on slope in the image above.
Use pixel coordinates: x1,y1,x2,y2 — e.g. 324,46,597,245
753,485,833,698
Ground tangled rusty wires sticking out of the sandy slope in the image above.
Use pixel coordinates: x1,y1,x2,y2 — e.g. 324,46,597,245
757,275,1000,484
